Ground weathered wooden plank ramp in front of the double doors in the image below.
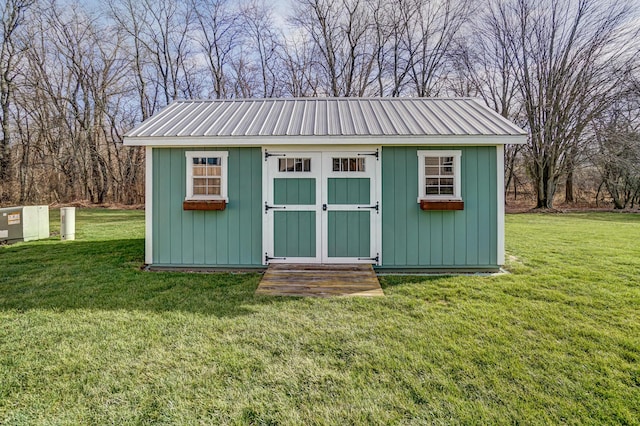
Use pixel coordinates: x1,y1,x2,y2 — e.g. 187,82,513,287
256,263,384,297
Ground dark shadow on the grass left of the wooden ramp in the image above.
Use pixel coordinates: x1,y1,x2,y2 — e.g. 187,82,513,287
0,239,290,317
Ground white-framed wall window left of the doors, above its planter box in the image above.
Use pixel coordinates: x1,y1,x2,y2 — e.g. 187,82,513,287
185,151,229,201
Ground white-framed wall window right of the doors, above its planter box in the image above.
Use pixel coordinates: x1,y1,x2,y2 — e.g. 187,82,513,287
418,151,462,202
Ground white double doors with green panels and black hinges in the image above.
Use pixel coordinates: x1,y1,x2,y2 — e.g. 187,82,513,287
263,148,381,264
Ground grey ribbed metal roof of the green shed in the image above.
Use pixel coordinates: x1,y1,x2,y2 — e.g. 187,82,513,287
125,98,526,145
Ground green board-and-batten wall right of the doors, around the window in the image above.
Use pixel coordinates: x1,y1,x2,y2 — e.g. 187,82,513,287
380,146,498,269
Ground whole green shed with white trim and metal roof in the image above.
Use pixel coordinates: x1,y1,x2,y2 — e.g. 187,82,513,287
124,98,526,272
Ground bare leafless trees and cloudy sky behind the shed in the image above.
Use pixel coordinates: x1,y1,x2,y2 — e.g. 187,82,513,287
0,0,640,208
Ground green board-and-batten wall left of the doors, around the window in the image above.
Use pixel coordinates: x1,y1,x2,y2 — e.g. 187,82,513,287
152,147,263,267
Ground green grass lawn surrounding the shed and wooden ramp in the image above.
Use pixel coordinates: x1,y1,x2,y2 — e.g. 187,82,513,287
0,210,640,425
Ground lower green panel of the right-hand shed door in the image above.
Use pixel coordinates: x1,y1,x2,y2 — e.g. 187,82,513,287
327,211,371,257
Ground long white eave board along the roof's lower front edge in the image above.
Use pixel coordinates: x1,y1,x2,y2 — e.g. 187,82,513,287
124,134,527,147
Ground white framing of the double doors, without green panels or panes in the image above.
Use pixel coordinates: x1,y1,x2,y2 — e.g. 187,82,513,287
262,145,382,265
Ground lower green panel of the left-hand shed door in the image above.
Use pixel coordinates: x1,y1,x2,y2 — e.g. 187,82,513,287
273,211,316,257
